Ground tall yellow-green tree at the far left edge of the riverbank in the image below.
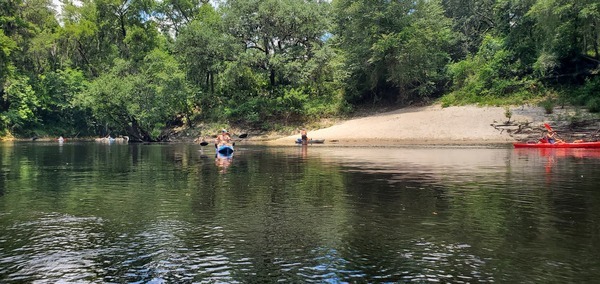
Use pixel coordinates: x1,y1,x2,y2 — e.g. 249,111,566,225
0,0,58,134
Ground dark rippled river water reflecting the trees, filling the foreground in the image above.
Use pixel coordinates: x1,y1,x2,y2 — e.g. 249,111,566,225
0,142,600,283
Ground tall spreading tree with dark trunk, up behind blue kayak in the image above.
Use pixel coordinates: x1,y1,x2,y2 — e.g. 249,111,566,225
224,0,329,87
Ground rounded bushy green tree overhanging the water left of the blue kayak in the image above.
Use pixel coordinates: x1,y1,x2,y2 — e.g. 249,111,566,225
77,49,190,141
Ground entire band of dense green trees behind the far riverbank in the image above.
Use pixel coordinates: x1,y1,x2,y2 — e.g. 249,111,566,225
0,0,600,141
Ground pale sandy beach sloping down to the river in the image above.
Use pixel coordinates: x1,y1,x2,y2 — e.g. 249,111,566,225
268,105,567,146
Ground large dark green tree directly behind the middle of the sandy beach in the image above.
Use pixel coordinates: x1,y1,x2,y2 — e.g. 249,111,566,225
333,0,453,102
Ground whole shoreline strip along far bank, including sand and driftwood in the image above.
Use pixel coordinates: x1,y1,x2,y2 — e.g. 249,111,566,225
0,104,600,147
